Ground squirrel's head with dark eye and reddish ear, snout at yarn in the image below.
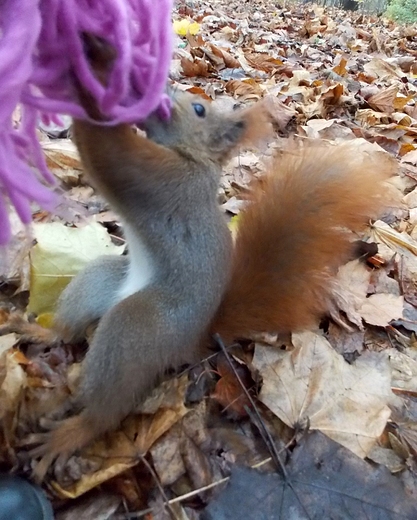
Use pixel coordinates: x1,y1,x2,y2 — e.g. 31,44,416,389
141,91,271,163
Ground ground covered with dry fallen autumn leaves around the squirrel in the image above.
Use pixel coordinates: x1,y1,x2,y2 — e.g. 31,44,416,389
0,0,417,520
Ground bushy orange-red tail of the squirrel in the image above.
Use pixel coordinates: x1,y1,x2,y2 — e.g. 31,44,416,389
211,143,394,341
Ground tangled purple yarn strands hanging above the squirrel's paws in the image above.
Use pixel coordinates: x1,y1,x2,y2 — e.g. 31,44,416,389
0,0,172,244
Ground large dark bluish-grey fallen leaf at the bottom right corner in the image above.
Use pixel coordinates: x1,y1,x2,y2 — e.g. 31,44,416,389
202,432,417,520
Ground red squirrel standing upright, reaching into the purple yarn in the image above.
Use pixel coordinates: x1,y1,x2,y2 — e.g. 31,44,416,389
30,37,392,468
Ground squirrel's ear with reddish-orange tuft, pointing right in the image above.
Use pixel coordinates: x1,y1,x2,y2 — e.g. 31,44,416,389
211,102,273,160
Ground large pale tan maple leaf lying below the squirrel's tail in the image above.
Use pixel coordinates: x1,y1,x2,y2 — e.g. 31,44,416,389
253,332,392,457
